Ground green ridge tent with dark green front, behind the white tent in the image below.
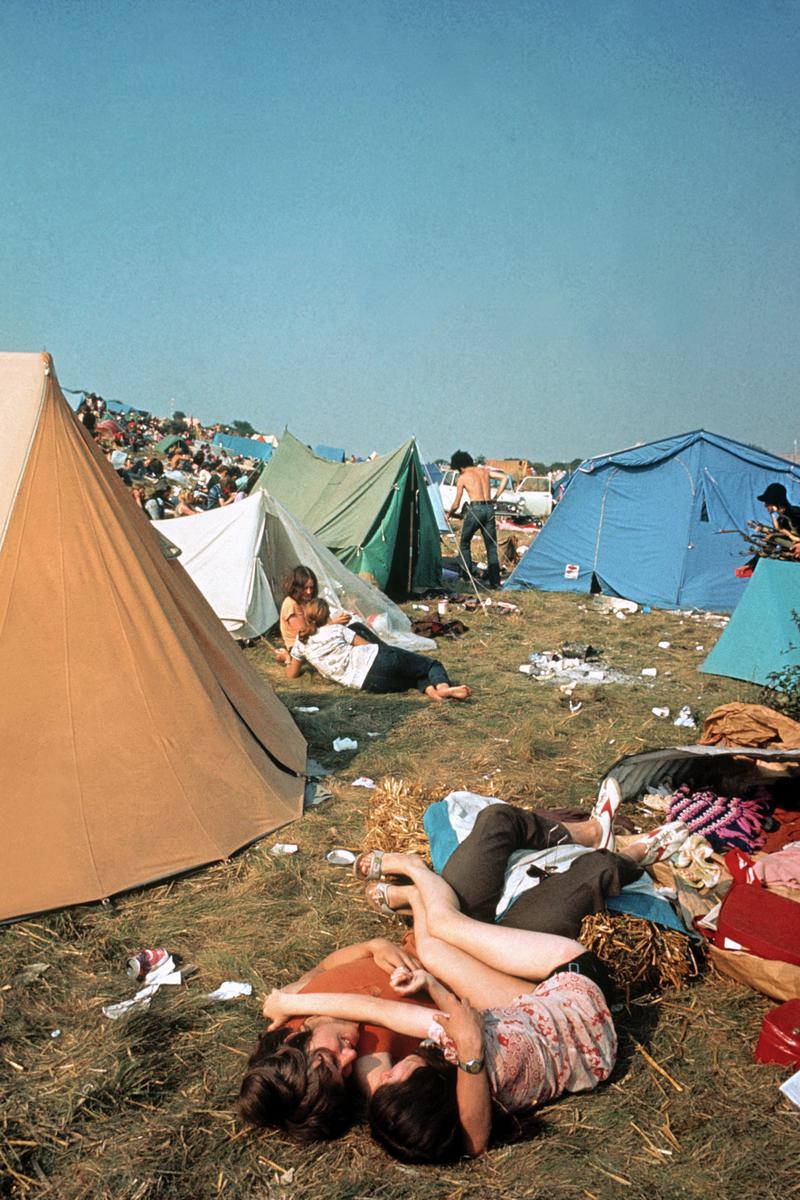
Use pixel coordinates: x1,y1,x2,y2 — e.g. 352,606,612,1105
255,431,441,595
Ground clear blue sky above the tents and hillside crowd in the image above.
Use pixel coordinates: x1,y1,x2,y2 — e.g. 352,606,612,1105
0,0,800,461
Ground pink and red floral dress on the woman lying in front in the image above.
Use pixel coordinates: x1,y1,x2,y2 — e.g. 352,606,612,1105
428,972,616,1112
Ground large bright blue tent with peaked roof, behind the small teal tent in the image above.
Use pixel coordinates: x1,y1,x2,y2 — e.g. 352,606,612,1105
505,430,800,612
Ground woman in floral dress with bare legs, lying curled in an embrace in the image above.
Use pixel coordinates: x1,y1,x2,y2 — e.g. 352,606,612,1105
264,853,616,1163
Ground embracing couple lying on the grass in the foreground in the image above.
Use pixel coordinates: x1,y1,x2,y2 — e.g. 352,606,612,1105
239,792,685,1163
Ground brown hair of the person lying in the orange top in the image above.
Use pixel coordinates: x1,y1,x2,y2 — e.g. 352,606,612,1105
236,1026,354,1141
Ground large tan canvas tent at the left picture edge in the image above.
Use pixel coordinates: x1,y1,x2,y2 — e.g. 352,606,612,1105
0,354,306,919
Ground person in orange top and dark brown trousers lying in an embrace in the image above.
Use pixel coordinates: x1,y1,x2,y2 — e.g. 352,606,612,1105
239,792,690,1141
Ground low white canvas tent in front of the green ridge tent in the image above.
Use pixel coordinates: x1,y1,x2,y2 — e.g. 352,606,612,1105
154,491,435,650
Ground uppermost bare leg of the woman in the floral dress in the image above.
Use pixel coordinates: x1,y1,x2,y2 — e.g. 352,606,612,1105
384,853,585,980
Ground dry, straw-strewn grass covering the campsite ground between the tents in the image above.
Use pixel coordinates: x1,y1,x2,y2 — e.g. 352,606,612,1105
0,594,800,1200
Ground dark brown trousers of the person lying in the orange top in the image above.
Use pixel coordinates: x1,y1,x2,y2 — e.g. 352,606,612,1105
441,804,642,937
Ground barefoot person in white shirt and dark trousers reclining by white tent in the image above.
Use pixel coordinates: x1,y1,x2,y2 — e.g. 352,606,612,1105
281,596,470,700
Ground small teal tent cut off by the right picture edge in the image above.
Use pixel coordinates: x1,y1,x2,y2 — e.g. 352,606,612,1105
700,558,800,685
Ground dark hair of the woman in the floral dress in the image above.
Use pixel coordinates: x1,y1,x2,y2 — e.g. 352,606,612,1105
367,1046,467,1163
